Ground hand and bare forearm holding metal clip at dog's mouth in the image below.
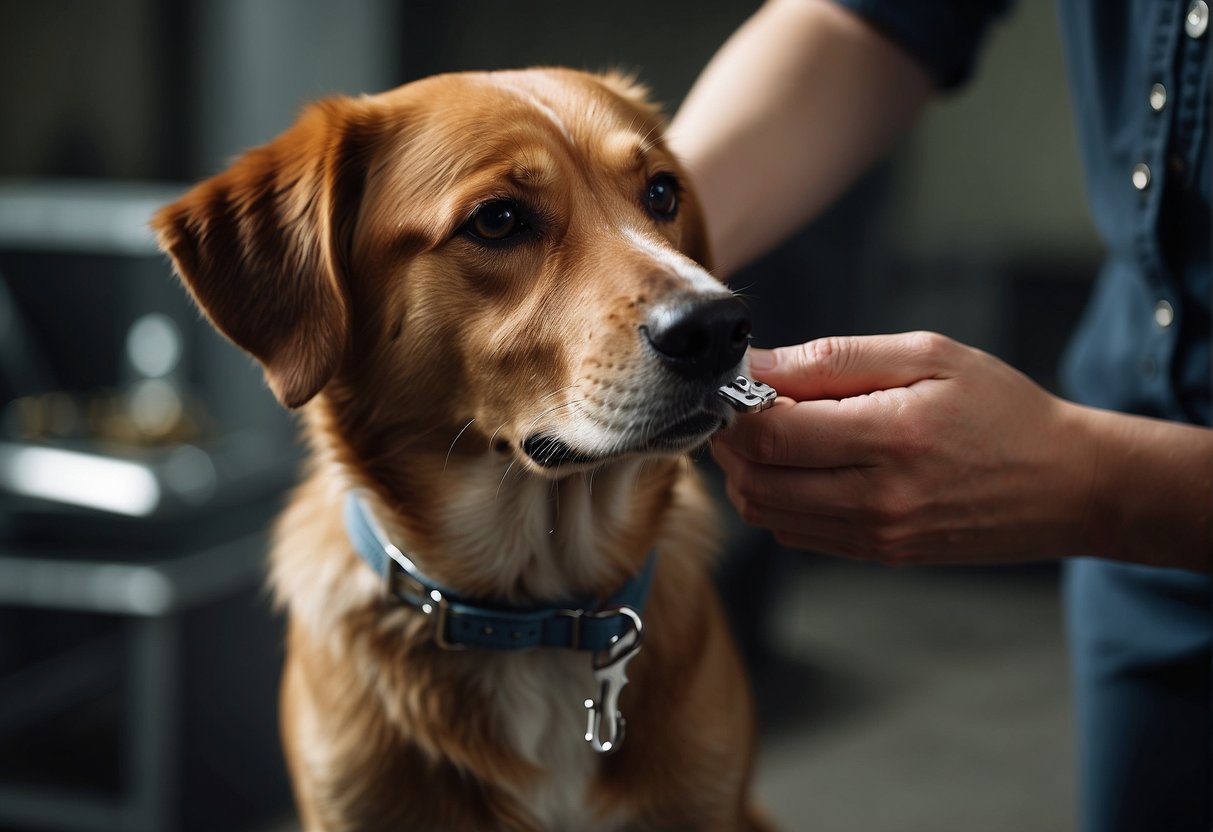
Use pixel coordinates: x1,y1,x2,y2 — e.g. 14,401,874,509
713,332,1213,572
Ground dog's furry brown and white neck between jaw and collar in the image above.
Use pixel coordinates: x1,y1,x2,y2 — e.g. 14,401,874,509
300,400,685,604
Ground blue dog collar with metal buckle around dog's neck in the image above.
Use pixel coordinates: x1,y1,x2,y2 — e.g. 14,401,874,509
344,491,656,651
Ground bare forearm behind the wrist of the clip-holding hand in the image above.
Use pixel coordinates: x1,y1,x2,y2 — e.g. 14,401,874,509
1072,406,1213,572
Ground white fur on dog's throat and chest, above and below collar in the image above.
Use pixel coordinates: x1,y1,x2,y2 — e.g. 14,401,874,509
444,462,638,832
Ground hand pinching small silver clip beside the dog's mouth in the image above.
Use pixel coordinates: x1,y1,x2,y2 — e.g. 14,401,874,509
713,332,1097,564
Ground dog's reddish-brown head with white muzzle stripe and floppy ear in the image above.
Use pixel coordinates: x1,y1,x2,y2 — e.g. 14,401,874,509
154,70,750,475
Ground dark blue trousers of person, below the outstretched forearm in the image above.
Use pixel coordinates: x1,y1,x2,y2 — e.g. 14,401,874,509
1065,559,1213,832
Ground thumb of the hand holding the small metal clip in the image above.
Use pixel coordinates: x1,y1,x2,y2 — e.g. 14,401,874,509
750,332,964,401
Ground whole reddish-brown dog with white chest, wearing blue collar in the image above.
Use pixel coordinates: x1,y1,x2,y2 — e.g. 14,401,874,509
153,69,763,832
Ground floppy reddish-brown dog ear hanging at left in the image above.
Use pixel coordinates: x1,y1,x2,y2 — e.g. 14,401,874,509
152,98,372,408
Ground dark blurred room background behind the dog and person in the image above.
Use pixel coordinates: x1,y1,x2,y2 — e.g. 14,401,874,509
0,0,1098,832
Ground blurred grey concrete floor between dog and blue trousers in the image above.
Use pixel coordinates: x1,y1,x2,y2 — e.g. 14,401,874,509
756,558,1075,832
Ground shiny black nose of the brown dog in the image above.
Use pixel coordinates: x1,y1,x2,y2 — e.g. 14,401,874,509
640,297,751,380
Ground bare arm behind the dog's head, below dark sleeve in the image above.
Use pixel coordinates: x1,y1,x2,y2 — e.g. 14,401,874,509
670,0,930,274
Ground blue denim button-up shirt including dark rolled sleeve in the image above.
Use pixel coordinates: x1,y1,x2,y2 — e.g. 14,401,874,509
838,0,1213,424
